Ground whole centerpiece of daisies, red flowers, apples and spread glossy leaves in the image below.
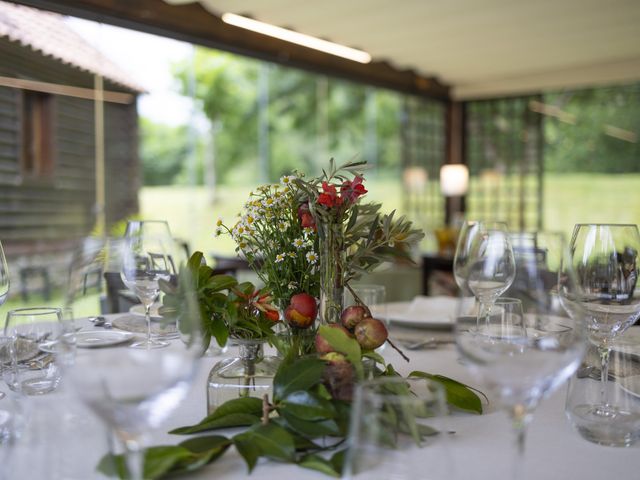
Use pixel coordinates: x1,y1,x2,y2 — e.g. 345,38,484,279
101,161,482,478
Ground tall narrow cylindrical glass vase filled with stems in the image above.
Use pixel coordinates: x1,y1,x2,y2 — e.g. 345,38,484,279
318,218,345,324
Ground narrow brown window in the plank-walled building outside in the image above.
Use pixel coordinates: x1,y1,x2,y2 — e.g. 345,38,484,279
22,91,53,177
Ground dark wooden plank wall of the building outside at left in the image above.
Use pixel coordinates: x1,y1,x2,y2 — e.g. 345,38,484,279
0,40,139,254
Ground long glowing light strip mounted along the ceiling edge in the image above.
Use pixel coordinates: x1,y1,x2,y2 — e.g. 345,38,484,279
222,13,371,63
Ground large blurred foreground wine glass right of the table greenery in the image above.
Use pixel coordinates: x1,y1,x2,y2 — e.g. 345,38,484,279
456,234,586,478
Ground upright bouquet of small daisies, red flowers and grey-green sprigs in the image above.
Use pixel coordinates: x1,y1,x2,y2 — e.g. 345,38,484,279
216,160,423,344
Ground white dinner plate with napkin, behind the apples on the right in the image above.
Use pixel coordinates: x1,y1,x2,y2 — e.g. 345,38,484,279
370,296,474,328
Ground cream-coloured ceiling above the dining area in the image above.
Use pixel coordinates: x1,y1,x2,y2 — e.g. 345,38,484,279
165,0,640,99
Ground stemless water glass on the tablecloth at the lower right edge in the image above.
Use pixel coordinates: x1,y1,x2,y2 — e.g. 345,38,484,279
565,327,640,447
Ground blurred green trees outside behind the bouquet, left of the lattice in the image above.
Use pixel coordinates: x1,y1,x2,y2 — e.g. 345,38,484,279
140,48,402,185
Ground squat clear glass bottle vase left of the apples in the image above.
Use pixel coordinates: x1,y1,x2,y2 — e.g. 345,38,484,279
207,339,280,415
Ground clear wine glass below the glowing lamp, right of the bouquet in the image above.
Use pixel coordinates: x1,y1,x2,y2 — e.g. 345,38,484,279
454,222,516,323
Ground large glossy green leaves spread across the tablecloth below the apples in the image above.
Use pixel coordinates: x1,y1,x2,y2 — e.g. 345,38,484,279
99,326,482,479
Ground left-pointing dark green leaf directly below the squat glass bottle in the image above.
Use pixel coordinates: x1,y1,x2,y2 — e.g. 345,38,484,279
169,397,262,435
